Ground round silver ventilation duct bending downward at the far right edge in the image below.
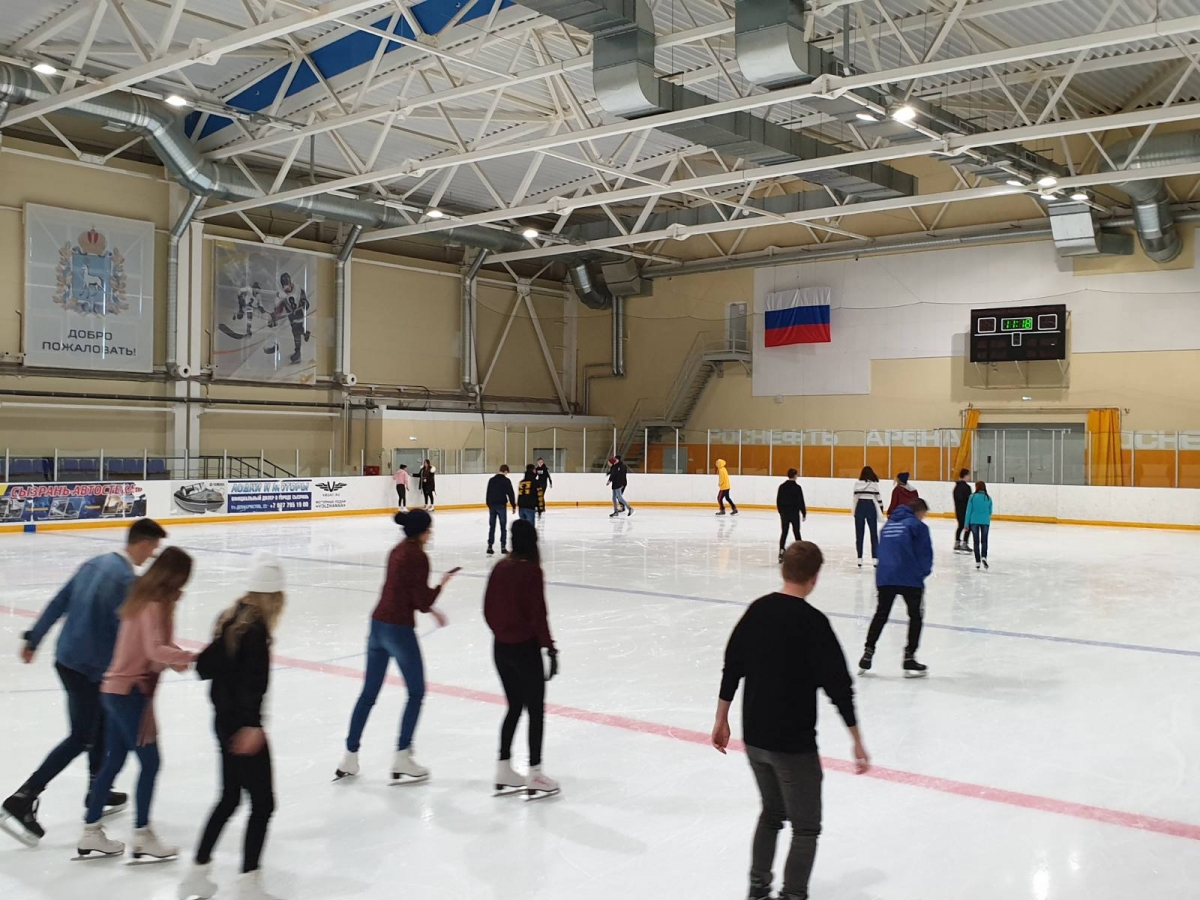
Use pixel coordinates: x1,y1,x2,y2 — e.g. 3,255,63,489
1100,131,1200,263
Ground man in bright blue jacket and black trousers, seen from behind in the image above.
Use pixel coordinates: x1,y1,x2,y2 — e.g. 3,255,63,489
858,498,934,678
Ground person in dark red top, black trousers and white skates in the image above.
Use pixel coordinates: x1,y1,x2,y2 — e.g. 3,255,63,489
484,520,559,797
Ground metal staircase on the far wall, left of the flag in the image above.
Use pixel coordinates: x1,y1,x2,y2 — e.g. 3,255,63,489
617,331,752,469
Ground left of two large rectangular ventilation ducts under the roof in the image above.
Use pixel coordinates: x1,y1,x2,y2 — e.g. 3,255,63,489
521,0,917,200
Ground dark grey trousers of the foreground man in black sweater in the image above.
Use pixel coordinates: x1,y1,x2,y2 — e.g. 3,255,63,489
746,746,823,900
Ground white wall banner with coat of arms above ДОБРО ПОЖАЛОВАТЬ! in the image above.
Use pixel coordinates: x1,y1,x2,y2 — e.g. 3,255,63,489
24,204,155,372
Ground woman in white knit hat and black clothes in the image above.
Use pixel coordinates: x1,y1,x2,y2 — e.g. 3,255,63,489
179,552,284,900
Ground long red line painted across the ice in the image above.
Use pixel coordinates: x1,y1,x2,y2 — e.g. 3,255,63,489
7,606,1200,841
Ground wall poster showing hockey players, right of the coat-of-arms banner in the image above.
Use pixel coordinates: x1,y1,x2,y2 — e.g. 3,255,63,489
212,241,325,384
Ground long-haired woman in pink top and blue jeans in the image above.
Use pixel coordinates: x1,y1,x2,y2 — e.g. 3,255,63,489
77,547,196,860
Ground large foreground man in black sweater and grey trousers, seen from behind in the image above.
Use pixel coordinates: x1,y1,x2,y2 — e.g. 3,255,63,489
713,541,870,900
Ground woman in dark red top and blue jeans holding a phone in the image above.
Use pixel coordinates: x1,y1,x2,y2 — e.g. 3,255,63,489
337,510,454,781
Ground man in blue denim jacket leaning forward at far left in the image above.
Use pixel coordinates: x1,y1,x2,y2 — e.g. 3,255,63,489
0,518,167,845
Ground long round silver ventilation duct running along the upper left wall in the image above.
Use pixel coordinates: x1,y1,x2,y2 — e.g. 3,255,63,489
0,64,529,251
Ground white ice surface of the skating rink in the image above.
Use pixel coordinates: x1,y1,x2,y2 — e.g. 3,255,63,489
0,509,1200,900
